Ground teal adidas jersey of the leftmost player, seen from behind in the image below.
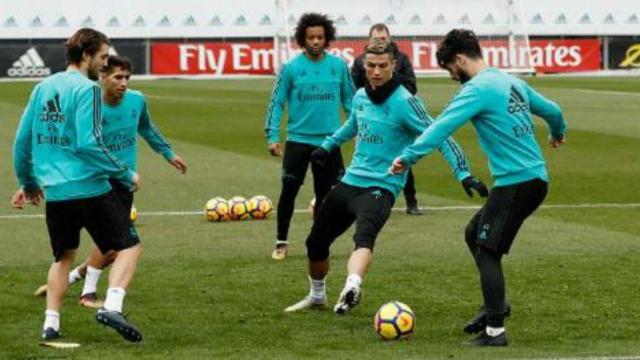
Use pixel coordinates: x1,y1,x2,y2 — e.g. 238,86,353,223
13,71,134,201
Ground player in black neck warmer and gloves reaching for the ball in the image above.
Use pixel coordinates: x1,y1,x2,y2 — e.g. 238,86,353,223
285,41,486,314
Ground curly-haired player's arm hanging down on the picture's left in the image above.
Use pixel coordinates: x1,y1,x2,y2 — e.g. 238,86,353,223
264,64,291,156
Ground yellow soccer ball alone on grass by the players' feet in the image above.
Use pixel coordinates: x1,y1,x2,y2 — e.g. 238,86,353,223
374,301,416,340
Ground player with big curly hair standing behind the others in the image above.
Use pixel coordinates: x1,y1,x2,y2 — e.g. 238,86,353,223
265,13,354,260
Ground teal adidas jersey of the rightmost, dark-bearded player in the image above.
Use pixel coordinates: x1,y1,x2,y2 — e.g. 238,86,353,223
402,68,566,186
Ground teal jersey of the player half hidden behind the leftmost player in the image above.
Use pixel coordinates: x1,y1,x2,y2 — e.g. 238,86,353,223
102,90,175,170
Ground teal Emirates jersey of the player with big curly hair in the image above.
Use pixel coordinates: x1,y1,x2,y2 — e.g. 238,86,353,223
265,52,354,146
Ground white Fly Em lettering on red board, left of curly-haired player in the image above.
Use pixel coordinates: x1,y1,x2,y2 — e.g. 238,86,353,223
179,43,274,75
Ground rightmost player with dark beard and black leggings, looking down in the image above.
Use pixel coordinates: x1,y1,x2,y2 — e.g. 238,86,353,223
390,29,566,346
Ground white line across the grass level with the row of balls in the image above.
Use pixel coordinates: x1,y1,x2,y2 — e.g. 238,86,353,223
0,203,640,219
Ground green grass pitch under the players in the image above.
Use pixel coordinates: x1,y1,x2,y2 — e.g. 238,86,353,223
0,74,640,359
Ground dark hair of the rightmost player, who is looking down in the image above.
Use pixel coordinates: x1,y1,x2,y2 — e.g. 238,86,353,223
436,29,482,68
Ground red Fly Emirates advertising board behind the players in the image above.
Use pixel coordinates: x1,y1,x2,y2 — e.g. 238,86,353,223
151,39,602,75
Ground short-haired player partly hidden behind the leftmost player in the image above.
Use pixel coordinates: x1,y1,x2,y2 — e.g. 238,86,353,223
35,56,187,308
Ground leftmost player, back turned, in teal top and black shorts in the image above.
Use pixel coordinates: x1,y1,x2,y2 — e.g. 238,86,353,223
12,28,142,341
